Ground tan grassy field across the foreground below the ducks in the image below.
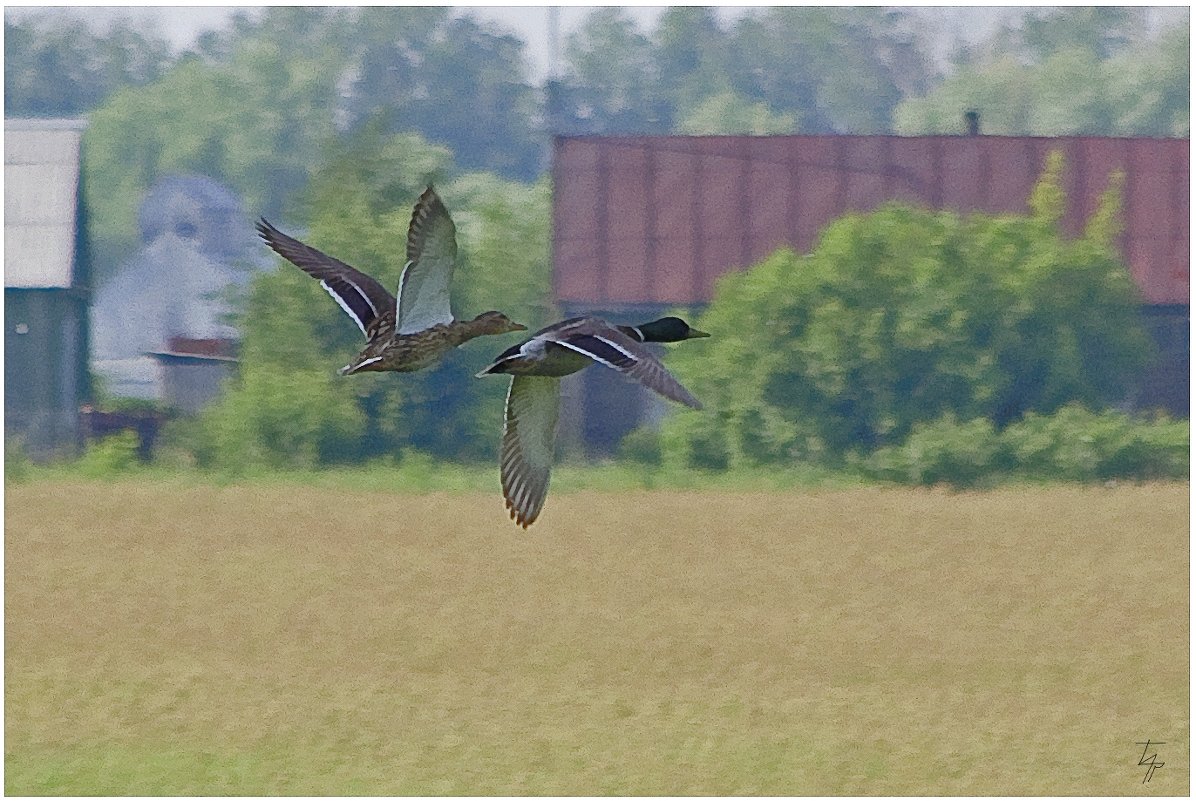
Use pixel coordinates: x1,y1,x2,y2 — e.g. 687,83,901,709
5,479,1190,795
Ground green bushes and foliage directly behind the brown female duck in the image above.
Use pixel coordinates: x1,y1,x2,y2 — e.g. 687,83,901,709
176,127,550,466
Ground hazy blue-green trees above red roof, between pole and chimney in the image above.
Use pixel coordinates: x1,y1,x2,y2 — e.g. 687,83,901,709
560,6,934,134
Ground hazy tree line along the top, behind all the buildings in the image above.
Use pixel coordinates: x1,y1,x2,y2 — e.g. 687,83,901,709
5,6,1189,277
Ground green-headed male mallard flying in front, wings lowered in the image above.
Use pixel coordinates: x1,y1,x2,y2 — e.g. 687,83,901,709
477,317,710,528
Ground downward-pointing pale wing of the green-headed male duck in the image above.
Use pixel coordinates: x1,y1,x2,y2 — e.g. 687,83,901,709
500,375,561,528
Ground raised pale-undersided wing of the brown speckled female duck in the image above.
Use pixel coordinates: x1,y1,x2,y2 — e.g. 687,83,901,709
395,185,457,334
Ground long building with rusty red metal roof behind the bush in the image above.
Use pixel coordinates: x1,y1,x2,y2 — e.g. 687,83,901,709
553,135,1190,451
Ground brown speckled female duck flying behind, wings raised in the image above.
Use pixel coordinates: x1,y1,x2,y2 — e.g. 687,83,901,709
257,185,527,375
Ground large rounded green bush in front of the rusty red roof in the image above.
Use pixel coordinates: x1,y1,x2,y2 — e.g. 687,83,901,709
663,158,1151,467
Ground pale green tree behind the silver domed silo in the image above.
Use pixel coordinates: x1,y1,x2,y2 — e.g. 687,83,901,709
84,22,338,275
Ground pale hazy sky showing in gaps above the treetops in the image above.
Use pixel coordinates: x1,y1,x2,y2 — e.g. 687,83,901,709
5,6,1020,80
